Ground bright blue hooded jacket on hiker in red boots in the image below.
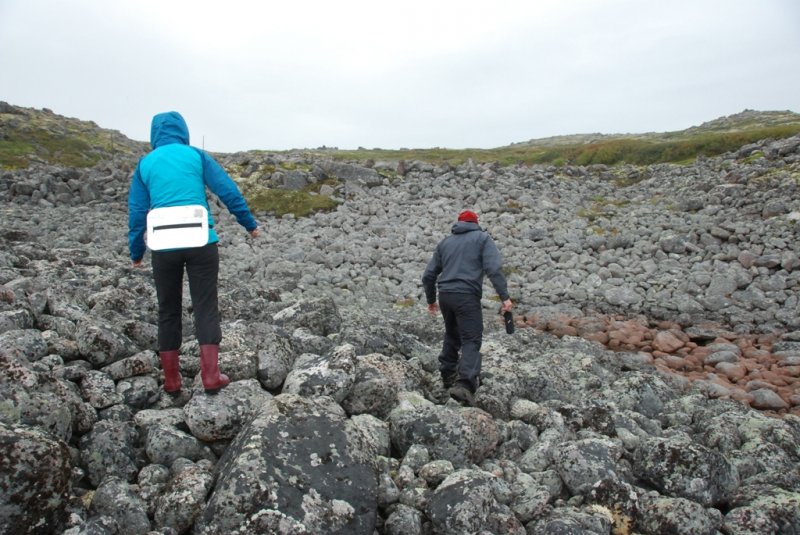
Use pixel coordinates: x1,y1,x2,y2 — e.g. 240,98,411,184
128,111,258,261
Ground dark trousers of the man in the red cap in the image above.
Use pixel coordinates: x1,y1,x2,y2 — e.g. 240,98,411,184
439,293,483,392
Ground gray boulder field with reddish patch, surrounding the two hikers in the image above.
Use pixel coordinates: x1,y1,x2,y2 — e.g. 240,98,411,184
0,137,800,535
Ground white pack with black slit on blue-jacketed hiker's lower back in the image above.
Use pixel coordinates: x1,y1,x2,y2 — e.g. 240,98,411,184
146,204,208,251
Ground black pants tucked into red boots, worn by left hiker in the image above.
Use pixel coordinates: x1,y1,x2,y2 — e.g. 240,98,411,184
152,243,222,351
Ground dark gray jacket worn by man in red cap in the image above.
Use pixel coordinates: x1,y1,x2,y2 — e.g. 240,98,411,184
422,221,509,304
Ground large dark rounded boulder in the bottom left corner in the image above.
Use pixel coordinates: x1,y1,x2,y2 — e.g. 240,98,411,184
0,422,72,535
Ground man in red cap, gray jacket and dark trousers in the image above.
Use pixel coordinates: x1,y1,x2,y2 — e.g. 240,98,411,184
422,210,512,405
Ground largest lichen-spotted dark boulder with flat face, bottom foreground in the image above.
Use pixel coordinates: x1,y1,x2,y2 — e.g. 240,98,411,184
195,394,377,535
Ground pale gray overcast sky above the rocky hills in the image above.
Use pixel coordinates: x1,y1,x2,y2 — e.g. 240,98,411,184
0,0,800,152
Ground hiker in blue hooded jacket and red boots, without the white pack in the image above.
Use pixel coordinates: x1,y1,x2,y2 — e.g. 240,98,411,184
128,111,259,395
